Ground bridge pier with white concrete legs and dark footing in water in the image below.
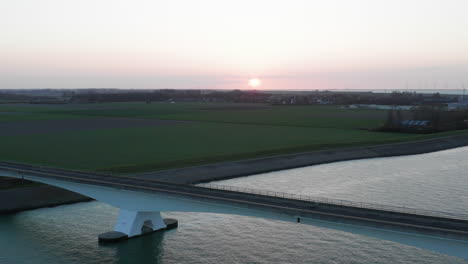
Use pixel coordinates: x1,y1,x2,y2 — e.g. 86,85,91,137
99,209,177,242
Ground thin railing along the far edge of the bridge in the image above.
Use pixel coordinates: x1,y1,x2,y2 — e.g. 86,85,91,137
197,183,468,220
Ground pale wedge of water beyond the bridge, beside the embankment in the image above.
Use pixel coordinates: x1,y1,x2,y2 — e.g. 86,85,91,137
216,147,468,214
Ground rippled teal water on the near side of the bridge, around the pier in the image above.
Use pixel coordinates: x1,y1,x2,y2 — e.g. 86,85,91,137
0,202,468,264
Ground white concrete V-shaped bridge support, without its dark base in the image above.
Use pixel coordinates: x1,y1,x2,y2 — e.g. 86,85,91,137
115,209,166,237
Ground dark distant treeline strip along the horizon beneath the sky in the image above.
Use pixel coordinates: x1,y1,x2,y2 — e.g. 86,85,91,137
0,89,457,105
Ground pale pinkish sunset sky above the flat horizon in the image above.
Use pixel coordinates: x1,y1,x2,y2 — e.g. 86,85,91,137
0,0,468,90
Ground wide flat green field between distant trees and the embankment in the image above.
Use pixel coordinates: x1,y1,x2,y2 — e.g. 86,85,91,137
0,103,466,173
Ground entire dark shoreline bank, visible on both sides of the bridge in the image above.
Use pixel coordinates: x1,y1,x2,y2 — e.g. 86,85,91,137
0,134,468,214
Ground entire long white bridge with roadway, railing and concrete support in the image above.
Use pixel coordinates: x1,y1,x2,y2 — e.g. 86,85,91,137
0,162,468,259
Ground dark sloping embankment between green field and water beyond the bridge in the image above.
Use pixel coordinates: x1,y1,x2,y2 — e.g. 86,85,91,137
135,134,468,184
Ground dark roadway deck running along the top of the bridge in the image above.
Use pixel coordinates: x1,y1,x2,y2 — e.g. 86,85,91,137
0,162,468,241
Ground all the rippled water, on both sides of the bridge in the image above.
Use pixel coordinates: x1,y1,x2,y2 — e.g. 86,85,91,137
0,148,468,264
